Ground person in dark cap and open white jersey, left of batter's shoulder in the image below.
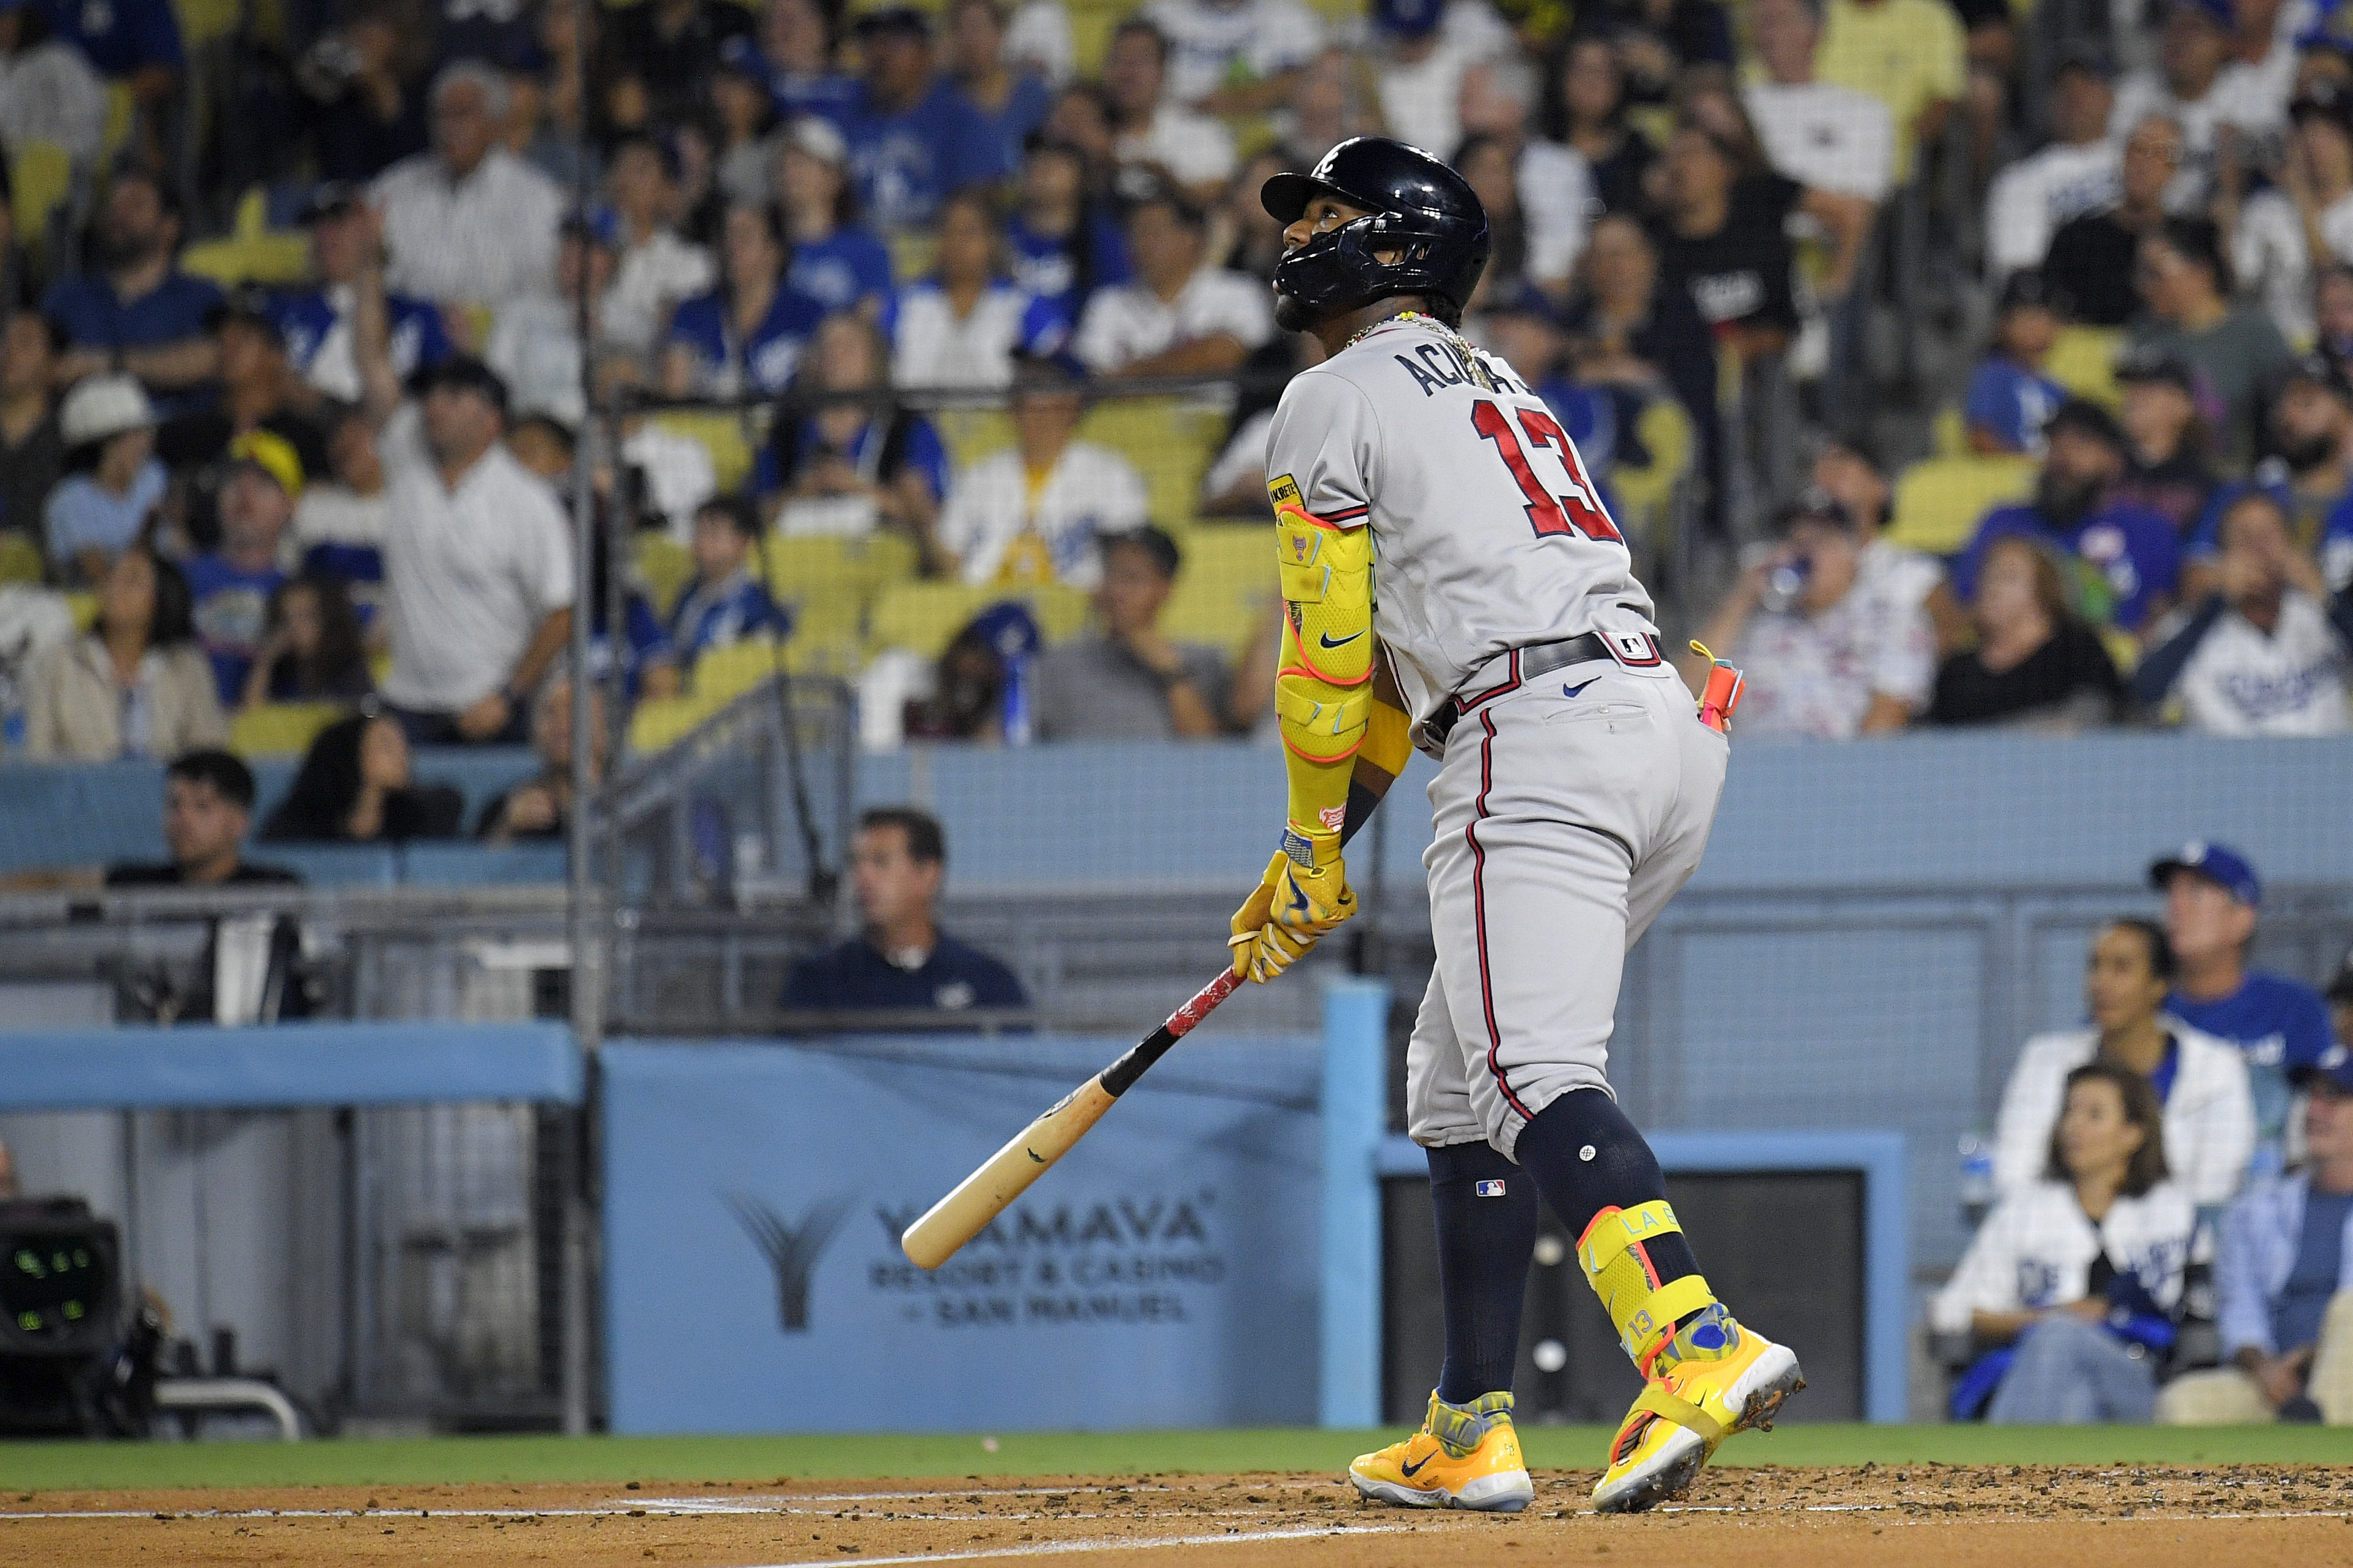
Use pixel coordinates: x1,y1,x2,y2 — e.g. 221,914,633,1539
939,355,1152,590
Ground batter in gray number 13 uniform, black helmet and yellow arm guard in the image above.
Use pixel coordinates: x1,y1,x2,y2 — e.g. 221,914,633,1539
1233,136,1805,1512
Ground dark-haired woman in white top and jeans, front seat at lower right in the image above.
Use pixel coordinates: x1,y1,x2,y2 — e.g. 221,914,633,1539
1930,1063,2195,1424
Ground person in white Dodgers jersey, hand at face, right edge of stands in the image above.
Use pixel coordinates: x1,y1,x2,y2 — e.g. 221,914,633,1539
2132,487,2353,736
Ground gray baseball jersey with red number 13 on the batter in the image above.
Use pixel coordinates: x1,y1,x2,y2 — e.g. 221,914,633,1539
1266,318,1656,720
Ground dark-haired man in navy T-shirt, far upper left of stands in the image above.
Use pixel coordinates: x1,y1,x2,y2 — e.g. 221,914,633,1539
40,169,221,418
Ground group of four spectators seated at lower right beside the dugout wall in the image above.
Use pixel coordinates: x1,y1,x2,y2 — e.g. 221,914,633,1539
1927,842,2353,1424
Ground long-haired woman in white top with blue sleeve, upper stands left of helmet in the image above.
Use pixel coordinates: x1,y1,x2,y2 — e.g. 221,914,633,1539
892,191,1070,388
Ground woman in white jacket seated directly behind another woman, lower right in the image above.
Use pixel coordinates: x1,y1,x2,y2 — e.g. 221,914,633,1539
1993,919,2254,1208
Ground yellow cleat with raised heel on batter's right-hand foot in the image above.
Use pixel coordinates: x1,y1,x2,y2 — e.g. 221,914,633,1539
1593,1307,1805,1514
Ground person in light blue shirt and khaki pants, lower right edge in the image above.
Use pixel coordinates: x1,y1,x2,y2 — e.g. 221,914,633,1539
2157,1044,2353,1427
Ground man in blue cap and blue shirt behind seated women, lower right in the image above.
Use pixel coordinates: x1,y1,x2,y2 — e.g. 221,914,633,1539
2148,839,2332,1178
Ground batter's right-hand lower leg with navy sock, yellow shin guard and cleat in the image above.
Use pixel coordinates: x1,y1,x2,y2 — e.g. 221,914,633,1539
1515,1088,1805,1514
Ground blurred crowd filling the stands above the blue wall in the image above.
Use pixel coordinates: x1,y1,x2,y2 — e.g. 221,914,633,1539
0,0,2353,785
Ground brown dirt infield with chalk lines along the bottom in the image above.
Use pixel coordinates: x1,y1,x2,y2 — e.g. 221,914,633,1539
0,1465,2353,1568
